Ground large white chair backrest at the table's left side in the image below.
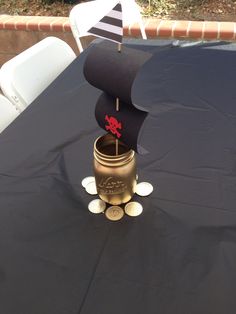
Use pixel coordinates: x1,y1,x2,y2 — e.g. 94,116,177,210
0,37,76,111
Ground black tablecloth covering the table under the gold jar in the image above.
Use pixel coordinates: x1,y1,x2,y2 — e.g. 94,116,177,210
0,39,236,314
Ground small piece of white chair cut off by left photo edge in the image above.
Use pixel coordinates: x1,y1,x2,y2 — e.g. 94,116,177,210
0,94,20,133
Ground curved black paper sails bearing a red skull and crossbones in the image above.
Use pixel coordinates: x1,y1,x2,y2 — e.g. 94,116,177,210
84,42,151,154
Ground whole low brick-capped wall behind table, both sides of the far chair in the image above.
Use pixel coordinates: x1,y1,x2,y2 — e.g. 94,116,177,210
0,15,236,65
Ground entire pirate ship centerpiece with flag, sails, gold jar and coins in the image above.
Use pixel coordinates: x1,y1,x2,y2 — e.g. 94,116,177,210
80,3,152,220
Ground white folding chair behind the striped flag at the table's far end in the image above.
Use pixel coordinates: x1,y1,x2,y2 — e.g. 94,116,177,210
69,0,147,52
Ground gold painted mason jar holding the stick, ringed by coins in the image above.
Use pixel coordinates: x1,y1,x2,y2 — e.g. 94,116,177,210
94,134,137,205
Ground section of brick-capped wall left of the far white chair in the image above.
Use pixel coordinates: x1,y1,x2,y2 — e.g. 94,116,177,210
0,15,93,66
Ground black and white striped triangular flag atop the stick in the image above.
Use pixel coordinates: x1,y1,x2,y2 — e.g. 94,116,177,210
88,2,123,43
